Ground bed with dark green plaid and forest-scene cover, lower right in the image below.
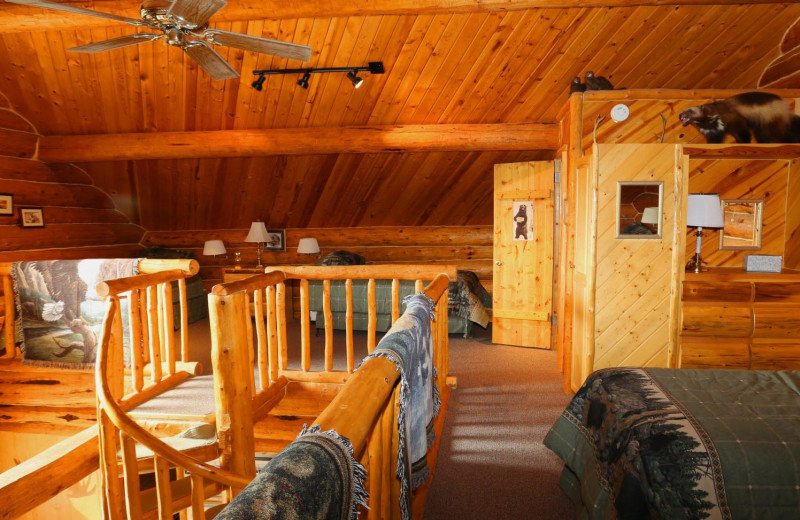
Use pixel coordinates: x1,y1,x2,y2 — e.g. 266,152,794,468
545,368,800,520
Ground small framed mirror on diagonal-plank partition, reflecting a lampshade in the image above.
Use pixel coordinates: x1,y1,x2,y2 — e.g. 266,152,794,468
617,181,664,239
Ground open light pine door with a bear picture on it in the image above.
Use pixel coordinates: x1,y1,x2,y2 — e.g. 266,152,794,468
492,162,554,349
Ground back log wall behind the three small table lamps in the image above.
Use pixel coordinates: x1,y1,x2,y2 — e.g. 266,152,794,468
142,225,492,296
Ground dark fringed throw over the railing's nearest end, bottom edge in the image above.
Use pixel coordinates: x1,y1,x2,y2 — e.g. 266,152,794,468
216,426,367,520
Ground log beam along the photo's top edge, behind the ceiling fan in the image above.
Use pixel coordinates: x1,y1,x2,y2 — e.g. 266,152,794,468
0,0,800,33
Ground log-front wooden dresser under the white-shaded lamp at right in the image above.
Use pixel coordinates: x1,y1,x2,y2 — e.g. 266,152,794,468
681,267,800,370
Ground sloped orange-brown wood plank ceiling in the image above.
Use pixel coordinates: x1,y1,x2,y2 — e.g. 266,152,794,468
0,1,800,230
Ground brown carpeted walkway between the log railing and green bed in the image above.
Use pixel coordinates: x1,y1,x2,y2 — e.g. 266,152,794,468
425,328,575,520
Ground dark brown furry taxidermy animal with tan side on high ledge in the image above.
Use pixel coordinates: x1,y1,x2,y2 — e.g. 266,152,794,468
679,92,800,143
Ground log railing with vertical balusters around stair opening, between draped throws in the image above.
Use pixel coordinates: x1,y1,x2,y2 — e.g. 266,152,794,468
209,266,455,519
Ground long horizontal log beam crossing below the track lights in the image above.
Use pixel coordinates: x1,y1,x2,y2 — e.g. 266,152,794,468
37,123,560,163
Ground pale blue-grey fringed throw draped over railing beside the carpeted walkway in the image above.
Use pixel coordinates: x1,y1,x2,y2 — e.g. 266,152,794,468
367,293,440,519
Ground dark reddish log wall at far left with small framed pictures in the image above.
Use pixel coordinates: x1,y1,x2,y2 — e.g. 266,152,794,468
0,97,144,348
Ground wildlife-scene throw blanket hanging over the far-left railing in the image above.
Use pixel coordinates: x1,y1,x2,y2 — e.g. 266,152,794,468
11,258,139,368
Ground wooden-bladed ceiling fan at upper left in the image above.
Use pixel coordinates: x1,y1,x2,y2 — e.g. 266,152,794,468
6,0,311,79
